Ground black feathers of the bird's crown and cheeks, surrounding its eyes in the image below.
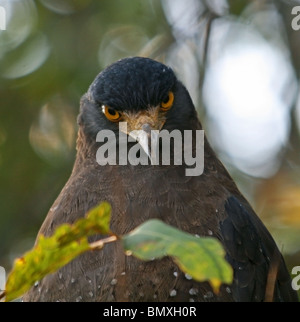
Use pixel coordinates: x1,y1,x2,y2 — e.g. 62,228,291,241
78,57,199,140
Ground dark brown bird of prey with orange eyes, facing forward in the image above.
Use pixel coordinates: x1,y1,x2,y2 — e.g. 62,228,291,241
23,57,297,301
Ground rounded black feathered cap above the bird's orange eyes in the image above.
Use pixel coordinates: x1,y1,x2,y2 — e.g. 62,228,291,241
88,57,176,111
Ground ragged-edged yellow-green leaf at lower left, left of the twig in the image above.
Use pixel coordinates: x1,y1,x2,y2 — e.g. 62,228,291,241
5,202,111,302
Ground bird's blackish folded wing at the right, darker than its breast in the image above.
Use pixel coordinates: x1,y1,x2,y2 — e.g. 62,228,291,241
220,196,298,301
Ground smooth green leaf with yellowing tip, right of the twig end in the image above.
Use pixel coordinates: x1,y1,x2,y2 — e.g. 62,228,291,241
122,219,233,292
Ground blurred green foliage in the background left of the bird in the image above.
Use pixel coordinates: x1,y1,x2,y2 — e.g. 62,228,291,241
0,0,170,268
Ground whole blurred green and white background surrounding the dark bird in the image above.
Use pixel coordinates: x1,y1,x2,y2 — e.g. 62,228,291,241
0,0,300,292
